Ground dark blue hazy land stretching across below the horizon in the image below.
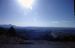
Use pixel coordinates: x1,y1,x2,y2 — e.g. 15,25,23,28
0,24,75,40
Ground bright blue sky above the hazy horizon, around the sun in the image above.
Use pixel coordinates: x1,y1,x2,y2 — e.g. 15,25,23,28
0,0,75,27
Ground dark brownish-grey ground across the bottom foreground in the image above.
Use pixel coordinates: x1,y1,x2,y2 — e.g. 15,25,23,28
0,35,75,48
